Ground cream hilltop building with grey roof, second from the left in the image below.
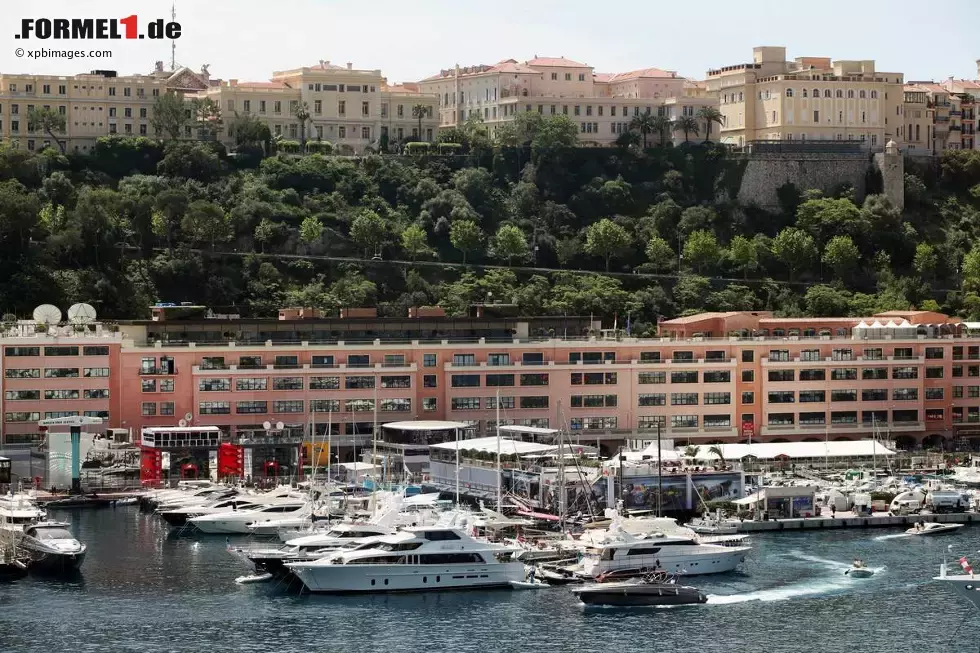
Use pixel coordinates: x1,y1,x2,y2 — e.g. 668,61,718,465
197,61,439,153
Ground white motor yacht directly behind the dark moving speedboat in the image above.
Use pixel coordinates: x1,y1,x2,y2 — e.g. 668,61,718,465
576,525,751,577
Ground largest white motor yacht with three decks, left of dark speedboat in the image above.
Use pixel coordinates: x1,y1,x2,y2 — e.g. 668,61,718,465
286,525,524,593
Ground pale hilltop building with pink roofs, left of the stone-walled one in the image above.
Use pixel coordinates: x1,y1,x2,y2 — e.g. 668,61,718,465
419,56,718,145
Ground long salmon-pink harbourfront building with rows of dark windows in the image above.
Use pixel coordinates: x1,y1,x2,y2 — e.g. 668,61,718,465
0,305,980,454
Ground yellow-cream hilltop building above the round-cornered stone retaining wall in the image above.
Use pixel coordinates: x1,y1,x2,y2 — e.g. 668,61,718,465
706,47,904,148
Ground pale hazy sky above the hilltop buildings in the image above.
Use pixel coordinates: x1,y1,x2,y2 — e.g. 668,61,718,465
0,0,980,83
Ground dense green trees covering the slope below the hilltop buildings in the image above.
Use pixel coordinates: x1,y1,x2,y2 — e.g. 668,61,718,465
0,116,980,333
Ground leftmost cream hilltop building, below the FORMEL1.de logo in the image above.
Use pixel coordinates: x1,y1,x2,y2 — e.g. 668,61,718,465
0,62,210,152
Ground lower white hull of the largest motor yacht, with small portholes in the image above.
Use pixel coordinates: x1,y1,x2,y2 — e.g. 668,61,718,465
287,562,524,594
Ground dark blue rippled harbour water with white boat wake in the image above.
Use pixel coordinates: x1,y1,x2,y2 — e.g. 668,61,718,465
0,507,980,653
